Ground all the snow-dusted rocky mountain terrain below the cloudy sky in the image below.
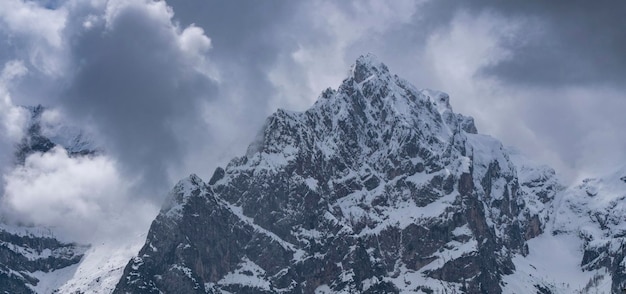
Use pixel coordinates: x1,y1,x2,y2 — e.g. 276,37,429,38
0,55,626,294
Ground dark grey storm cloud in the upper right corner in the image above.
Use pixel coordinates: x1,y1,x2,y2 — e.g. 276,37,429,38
338,0,626,87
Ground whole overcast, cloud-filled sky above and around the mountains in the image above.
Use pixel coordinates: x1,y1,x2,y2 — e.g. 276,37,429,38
0,0,626,241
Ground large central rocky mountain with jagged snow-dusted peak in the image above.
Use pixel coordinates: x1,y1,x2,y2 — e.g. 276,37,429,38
114,55,556,293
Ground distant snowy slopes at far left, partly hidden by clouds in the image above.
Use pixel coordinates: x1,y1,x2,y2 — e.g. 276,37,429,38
0,105,145,294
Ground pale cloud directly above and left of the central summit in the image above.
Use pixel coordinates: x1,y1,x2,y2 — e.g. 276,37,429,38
268,0,421,111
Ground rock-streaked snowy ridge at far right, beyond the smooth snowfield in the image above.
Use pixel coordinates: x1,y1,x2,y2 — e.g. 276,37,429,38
552,167,626,293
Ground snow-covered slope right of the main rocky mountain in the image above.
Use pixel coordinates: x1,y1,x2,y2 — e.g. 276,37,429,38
505,155,626,293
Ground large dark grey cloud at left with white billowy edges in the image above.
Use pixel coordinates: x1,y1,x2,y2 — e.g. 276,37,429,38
61,1,215,192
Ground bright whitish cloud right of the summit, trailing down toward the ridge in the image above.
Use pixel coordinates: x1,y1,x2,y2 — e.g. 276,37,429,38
414,11,572,178
